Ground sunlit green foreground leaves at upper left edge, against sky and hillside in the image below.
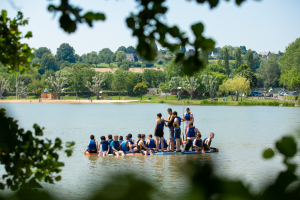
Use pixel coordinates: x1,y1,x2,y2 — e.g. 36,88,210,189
0,10,38,74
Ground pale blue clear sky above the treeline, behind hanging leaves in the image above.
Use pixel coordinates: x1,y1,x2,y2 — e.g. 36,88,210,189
0,0,300,55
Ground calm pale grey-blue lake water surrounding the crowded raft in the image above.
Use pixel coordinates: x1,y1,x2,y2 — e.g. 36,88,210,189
0,103,300,199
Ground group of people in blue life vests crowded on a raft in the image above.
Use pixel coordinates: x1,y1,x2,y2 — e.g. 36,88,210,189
86,108,218,156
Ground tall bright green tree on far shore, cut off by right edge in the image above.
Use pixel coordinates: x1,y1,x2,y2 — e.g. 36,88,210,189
279,38,300,89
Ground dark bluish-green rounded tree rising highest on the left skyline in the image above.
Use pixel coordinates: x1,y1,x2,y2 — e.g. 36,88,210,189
55,43,75,63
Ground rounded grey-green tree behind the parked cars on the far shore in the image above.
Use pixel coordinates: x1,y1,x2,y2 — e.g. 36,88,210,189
258,55,280,87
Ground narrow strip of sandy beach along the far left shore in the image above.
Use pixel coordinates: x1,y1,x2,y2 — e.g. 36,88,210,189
0,99,138,103
